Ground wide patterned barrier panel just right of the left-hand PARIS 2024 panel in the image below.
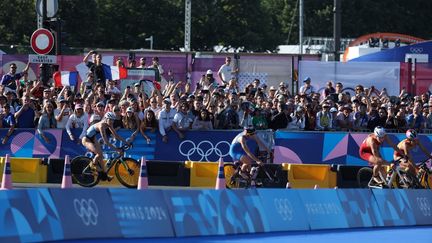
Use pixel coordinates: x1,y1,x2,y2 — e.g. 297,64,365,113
163,190,269,236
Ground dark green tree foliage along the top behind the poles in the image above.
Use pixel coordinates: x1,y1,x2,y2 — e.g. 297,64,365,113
0,0,432,51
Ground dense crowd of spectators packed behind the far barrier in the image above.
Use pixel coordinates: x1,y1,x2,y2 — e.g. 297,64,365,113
0,52,432,144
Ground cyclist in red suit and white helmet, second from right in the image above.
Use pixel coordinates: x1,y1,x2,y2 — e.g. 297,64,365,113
359,126,404,185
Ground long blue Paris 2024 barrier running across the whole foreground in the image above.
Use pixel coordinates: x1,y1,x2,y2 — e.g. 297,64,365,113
0,189,432,242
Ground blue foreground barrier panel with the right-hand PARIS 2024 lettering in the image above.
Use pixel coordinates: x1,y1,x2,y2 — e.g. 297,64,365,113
298,189,348,230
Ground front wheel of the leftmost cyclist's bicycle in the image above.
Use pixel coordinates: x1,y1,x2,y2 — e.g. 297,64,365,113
115,158,141,188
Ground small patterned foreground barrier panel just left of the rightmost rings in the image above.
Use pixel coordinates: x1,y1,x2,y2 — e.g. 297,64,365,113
372,189,416,226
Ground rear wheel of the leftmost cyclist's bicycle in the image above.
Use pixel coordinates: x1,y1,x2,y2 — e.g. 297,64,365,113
71,156,100,187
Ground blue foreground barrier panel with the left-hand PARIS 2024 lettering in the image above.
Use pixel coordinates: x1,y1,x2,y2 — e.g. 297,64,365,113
109,189,175,237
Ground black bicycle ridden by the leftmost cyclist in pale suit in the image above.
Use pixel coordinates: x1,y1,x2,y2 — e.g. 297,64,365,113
71,145,141,188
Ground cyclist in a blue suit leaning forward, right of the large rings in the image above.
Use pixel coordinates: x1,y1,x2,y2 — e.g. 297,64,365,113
229,126,271,177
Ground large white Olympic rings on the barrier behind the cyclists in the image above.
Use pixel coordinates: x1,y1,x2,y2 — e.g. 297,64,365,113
178,140,231,161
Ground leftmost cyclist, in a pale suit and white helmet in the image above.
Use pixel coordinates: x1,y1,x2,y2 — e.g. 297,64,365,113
82,112,130,180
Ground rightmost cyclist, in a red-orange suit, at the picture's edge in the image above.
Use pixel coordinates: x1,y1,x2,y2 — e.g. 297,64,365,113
393,129,432,175
